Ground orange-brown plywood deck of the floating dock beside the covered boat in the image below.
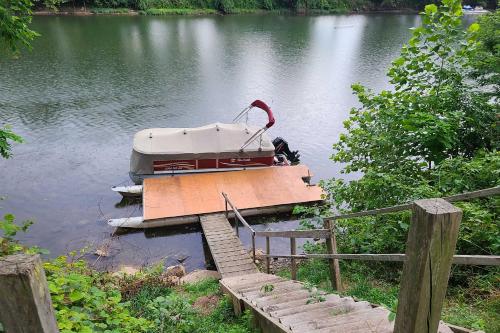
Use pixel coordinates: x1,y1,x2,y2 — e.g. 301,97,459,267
143,165,323,220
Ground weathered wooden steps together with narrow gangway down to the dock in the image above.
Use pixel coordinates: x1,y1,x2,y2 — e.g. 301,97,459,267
200,214,453,333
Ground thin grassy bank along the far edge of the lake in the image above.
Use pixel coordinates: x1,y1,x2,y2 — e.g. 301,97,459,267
32,8,420,16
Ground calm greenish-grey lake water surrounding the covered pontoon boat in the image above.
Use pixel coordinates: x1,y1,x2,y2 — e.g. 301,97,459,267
0,14,419,269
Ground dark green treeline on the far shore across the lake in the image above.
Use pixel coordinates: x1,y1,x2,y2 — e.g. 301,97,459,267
33,0,497,14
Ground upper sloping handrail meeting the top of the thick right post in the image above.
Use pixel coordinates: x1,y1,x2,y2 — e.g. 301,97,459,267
323,186,500,220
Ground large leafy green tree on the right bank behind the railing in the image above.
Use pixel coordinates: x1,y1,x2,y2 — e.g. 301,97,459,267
323,0,500,254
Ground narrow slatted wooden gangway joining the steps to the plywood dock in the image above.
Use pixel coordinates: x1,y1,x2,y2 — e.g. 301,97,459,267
200,214,258,278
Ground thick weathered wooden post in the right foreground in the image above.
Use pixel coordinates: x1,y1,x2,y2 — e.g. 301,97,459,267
394,199,462,333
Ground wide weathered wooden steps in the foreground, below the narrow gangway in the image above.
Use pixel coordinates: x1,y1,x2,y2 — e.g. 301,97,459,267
220,273,453,333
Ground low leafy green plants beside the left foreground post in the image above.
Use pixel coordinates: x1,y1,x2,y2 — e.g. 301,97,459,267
44,256,153,333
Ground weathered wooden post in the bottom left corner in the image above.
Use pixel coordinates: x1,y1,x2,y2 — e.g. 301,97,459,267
0,254,59,333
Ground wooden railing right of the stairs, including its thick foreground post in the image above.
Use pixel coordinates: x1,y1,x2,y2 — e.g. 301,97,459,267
223,186,500,333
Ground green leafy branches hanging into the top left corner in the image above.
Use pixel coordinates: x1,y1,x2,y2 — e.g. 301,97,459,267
0,0,38,52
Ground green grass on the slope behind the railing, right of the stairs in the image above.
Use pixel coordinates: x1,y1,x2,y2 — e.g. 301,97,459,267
278,259,500,333
